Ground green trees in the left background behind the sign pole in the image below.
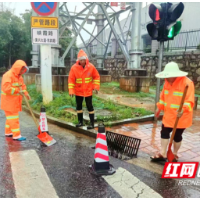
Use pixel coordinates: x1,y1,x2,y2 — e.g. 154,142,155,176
0,10,77,69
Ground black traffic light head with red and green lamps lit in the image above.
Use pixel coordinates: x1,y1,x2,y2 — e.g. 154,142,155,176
147,3,184,41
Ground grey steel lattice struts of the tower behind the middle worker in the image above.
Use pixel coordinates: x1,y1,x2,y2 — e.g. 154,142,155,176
59,2,135,62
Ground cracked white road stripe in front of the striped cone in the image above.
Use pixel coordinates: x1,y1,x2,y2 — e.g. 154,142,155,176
103,168,162,198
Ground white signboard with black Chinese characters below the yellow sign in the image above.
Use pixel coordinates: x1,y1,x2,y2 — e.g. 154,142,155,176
32,28,58,45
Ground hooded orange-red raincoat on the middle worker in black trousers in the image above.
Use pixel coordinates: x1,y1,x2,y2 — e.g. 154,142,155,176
68,50,100,97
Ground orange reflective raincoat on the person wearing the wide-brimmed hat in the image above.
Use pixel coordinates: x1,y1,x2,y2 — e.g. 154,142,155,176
157,77,194,129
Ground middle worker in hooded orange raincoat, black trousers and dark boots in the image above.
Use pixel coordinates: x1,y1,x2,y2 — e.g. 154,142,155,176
68,50,100,129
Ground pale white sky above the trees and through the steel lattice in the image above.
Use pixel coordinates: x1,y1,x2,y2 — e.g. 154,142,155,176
0,2,151,44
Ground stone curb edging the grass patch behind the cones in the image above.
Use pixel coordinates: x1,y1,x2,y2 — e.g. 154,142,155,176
22,106,162,139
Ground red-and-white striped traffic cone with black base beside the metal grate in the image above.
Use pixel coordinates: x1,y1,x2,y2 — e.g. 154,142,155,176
90,124,116,175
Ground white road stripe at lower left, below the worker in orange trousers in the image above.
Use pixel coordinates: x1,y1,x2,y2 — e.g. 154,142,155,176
9,150,58,198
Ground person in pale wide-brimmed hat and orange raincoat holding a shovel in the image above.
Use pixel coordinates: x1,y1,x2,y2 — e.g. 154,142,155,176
151,62,194,162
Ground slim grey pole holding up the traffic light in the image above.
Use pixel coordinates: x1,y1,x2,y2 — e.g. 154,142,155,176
155,41,164,121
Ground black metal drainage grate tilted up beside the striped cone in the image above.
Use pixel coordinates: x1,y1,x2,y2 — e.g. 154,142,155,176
106,131,141,160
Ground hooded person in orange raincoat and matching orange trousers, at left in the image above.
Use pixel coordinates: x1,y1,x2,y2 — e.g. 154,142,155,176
1,60,31,141
